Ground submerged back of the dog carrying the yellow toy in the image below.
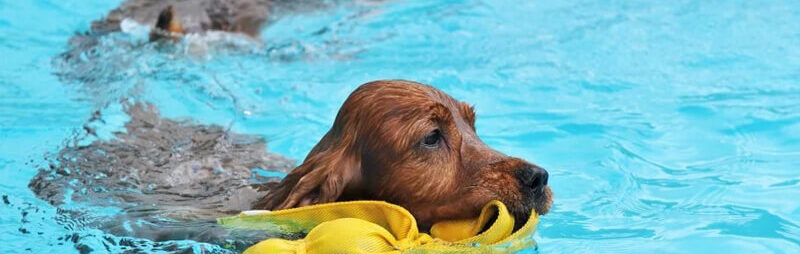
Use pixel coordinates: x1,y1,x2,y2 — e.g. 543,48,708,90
29,103,294,246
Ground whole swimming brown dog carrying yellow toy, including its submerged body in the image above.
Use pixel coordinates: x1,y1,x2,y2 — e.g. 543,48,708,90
29,81,552,249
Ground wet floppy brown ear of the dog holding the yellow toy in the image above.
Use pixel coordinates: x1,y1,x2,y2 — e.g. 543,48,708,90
256,133,361,210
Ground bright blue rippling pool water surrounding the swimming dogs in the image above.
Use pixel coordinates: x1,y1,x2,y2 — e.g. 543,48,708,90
0,0,800,253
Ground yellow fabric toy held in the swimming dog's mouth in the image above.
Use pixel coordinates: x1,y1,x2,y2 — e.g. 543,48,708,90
218,201,539,254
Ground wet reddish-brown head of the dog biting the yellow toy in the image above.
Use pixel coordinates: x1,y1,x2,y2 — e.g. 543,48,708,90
257,80,552,227
